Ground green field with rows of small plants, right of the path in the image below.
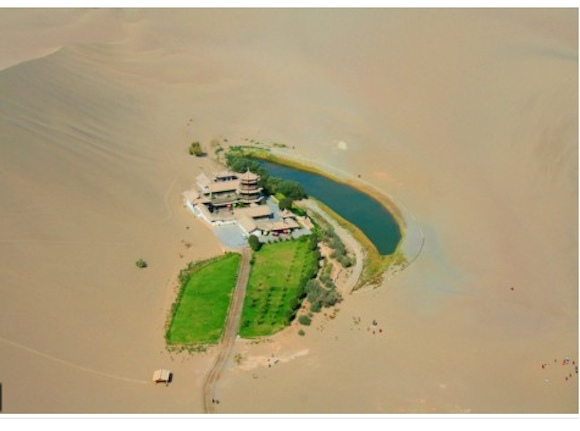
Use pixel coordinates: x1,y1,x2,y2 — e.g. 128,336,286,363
240,239,318,338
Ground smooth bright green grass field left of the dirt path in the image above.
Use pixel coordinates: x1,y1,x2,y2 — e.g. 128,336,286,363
166,253,241,344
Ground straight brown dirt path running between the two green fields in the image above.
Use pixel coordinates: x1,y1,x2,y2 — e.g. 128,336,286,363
203,247,252,413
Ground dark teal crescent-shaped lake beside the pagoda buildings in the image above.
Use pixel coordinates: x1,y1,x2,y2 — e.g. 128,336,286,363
260,161,401,255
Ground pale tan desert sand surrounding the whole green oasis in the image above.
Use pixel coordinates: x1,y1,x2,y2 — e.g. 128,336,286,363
0,9,578,414
